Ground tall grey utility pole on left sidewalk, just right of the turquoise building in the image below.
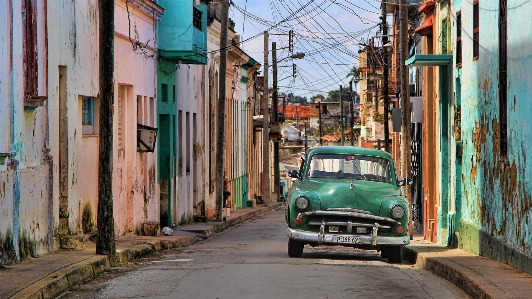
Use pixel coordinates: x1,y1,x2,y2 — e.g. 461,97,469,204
214,0,229,221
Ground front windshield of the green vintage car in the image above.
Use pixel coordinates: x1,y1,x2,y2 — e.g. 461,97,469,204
307,154,393,184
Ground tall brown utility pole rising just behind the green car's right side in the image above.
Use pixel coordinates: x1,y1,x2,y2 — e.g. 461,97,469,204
399,0,412,239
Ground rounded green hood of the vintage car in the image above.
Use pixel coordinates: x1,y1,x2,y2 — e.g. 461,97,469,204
302,179,401,215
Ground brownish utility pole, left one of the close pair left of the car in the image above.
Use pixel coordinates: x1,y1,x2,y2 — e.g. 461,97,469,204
262,31,271,205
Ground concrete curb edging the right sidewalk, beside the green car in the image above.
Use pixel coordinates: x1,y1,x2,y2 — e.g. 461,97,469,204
403,246,502,299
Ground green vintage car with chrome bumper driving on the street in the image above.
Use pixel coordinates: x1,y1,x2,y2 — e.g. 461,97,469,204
286,146,411,263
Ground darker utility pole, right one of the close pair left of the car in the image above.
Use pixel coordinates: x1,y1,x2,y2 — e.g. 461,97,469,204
272,42,281,202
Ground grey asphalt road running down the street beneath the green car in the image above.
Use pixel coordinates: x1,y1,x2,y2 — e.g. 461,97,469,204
60,210,470,299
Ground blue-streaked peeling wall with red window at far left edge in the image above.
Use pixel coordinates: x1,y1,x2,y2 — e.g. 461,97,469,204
0,0,53,264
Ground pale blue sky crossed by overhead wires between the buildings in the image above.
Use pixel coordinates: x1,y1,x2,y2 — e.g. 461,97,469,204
229,0,384,98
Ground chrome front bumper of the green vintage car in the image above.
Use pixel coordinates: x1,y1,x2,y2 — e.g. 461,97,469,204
286,227,410,246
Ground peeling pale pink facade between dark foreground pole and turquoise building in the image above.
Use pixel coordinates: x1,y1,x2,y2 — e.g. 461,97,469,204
114,0,161,235
